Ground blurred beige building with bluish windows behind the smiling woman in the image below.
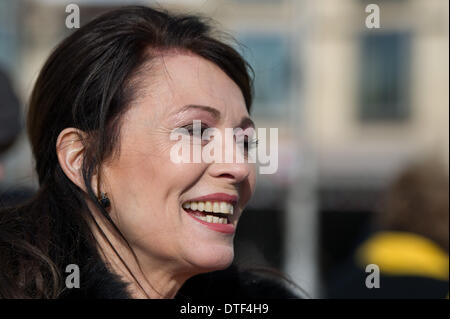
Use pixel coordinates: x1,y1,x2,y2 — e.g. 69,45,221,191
0,0,449,297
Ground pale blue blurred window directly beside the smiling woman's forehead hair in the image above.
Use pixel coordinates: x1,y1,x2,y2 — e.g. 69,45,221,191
239,34,291,118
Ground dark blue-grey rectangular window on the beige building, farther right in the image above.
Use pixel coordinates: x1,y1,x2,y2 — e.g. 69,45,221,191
359,32,410,121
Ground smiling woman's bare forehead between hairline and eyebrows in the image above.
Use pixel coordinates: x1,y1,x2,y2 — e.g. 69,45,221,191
134,53,247,120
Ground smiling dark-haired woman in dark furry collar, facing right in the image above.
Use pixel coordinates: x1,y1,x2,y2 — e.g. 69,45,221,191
0,7,300,298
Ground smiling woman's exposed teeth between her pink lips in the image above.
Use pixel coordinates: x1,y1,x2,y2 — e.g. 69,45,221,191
183,201,233,224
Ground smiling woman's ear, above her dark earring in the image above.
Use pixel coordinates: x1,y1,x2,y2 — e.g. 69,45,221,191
56,127,86,191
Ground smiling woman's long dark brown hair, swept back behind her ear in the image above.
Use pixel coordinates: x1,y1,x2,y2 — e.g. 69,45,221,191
0,6,252,298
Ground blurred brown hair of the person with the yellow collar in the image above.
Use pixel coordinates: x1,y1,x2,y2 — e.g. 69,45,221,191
377,158,449,252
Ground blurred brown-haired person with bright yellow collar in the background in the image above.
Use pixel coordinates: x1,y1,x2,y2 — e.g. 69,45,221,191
327,159,449,298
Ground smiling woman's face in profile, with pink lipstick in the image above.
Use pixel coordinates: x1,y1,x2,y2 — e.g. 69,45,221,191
102,54,255,273
